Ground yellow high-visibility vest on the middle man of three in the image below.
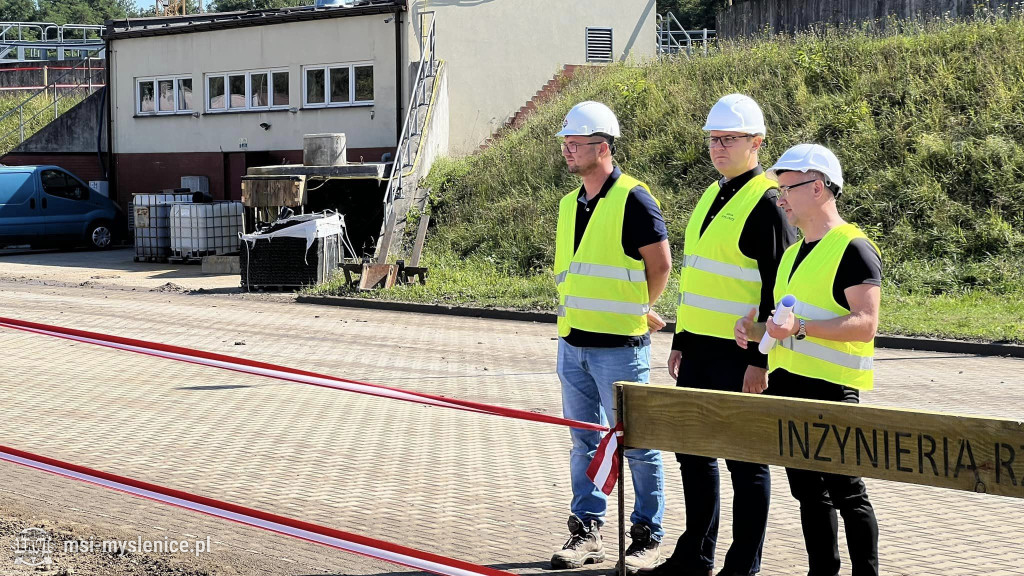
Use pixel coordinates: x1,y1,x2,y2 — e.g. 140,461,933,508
676,174,778,340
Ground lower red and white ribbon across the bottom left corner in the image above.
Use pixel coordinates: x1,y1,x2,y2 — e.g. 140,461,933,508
0,446,512,576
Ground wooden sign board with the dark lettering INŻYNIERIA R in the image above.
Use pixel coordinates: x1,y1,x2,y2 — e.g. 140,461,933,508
618,382,1024,498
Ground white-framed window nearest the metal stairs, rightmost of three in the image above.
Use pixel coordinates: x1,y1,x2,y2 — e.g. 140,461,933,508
302,64,374,108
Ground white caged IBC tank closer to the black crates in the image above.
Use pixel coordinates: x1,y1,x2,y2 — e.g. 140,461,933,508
170,202,243,257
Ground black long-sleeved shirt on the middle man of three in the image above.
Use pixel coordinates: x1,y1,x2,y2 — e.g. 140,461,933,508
672,166,797,368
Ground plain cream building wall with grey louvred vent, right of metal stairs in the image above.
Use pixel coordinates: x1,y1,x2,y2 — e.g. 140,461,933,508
403,0,656,154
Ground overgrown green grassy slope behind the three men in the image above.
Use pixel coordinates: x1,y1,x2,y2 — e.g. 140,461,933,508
309,14,1024,341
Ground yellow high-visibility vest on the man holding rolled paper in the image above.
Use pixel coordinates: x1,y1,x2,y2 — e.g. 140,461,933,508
768,223,882,390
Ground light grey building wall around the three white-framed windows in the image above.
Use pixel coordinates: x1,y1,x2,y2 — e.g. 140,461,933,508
111,14,397,154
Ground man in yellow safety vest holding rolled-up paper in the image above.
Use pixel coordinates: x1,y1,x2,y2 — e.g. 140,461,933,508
735,143,882,576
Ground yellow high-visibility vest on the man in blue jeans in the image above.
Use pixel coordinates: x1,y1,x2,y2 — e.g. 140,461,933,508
555,174,657,337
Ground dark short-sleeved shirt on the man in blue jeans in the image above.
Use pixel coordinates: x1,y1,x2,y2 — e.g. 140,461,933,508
564,167,669,348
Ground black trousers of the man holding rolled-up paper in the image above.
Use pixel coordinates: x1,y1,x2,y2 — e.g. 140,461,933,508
768,373,879,576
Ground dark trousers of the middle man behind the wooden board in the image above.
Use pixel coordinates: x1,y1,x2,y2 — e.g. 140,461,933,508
671,350,771,576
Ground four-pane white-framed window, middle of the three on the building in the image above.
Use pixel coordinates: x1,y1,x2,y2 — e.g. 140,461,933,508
206,70,289,112
